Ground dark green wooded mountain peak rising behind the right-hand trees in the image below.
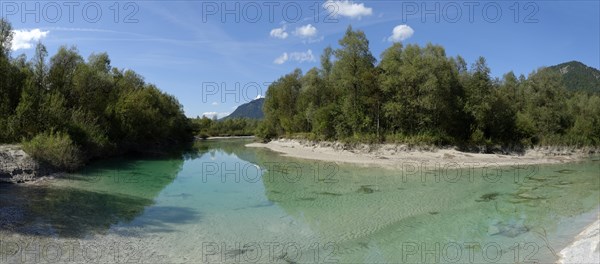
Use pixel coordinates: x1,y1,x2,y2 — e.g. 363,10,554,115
546,61,600,93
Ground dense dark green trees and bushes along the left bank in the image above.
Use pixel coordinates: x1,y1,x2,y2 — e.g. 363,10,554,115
0,20,193,170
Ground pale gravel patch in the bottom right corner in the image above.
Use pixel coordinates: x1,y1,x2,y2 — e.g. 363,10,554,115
558,219,600,264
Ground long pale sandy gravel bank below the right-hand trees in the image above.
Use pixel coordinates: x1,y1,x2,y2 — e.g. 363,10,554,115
246,139,595,168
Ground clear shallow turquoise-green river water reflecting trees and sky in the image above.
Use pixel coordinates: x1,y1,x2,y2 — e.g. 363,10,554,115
0,140,600,263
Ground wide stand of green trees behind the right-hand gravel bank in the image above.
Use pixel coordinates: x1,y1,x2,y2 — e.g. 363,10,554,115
256,27,600,148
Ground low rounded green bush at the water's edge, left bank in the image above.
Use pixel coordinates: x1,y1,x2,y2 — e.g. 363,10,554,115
23,131,82,171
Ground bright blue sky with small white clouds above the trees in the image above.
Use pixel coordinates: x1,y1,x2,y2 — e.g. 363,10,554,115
0,0,600,116
